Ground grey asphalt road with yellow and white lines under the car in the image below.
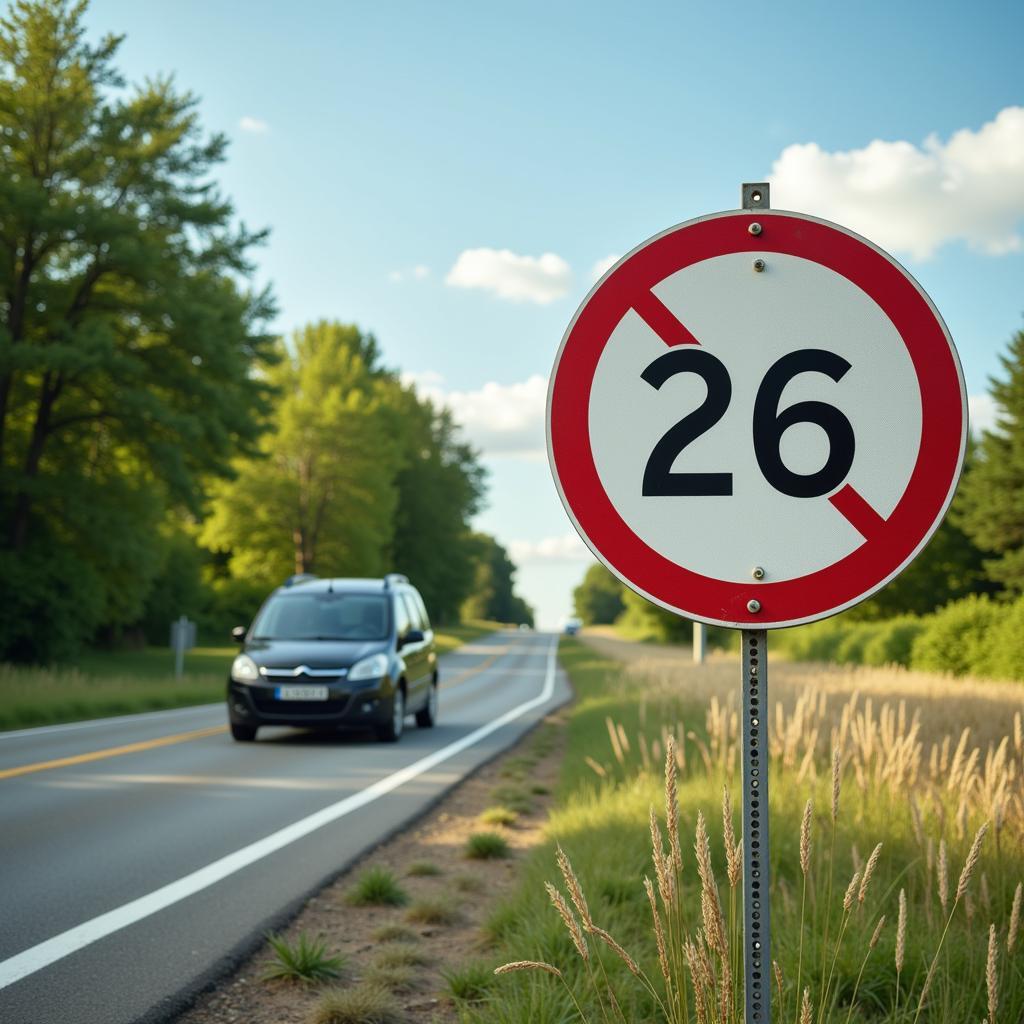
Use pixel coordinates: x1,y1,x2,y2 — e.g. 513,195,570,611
0,633,569,1024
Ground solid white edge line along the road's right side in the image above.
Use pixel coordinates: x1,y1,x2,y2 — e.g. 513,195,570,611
0,637,558,988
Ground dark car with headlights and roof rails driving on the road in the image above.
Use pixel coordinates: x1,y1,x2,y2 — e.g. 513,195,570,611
227,573,437,742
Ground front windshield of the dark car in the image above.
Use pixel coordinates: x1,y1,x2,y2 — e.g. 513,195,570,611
253,593,388,640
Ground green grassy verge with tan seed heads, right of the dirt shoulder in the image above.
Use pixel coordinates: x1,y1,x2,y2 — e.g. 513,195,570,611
473,641,1024,1024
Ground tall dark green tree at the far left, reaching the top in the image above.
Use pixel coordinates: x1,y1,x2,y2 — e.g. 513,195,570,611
0,0,272,658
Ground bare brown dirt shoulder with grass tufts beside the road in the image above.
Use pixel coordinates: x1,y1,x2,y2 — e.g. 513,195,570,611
174,712,564,1024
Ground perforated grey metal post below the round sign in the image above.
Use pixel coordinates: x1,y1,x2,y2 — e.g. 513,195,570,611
740,630,771,1024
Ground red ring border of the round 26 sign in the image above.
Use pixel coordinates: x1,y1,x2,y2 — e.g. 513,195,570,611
548,210,967,629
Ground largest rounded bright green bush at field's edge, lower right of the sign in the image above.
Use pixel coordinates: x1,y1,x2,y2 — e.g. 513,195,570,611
910,594,1006,676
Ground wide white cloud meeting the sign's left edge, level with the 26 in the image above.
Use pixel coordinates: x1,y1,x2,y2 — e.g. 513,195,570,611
402,371,548,460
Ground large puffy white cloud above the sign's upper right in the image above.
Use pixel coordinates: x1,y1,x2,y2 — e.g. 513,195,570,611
770,106,1024,260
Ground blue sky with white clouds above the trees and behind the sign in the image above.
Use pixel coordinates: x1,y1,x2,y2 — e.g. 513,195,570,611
88,0,1024,626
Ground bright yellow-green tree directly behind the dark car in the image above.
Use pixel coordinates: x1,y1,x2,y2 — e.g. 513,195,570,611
202,322,401,586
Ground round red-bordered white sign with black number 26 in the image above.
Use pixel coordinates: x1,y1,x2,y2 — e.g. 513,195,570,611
548,210,967,629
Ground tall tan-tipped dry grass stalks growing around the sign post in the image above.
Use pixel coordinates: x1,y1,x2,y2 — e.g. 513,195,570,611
491,638,1024,1024
